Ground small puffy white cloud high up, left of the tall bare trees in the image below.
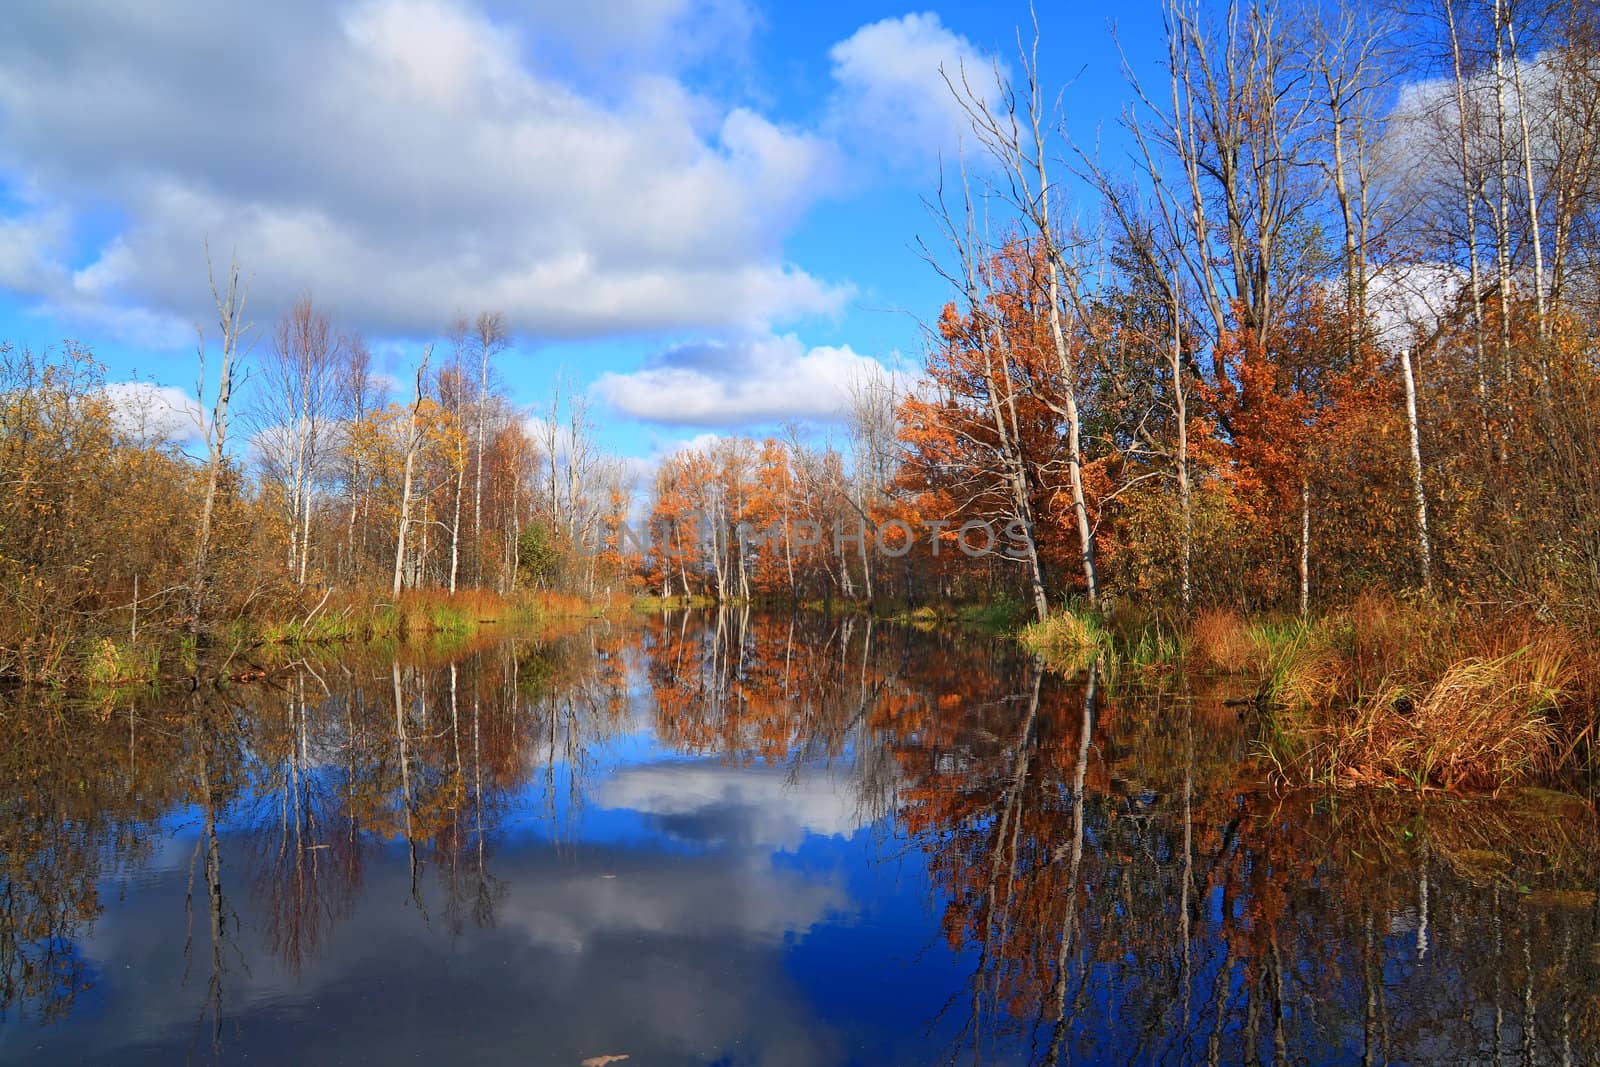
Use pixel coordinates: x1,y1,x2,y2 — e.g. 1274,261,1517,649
829,11,1005,160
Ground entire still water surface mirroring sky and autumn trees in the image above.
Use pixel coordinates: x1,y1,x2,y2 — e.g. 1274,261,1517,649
0,613,1600,1067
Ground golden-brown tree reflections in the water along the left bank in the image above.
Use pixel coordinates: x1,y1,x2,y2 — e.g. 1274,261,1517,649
0,632,627,1041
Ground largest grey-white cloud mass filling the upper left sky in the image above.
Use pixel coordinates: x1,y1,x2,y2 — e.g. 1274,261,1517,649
0,0,845,336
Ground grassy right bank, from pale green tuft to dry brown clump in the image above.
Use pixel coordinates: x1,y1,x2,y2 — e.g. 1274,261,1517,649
1019,595,1600,790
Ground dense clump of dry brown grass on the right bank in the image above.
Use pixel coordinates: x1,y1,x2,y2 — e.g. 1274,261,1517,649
1241,593,1600,790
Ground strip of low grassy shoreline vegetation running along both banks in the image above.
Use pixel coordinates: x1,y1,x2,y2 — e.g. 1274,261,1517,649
0,534,1600,793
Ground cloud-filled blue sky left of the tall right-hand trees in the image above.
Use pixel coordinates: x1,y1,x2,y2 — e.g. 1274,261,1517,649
0,0,1162,473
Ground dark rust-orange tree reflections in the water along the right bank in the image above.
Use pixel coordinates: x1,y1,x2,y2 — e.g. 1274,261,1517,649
880,643,1600,1062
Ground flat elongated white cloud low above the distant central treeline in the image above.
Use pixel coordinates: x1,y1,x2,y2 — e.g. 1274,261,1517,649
595,334,908,426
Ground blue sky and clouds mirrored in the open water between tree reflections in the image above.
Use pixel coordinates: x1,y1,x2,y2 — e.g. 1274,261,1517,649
0,736,960,1065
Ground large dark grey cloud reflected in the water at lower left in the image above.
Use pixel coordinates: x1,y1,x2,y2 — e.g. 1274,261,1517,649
64,833,859,1067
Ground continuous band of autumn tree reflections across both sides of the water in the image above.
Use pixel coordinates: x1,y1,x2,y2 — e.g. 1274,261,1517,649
9,611,1600,1062
